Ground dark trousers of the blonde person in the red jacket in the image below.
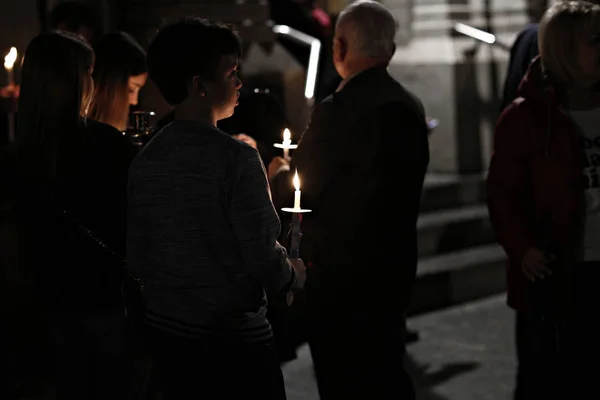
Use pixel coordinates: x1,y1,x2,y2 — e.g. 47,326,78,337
514,263,600,400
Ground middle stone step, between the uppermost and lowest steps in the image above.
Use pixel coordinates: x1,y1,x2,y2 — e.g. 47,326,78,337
417,204,495,257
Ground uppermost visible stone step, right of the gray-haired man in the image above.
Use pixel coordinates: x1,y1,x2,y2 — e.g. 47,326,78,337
421,173,485,213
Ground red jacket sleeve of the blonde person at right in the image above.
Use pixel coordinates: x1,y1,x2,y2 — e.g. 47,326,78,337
487,103,535,265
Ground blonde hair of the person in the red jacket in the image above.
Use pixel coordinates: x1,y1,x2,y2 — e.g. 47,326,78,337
538,1,600,84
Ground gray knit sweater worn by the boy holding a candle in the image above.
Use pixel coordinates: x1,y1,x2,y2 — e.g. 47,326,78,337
127,121,294,343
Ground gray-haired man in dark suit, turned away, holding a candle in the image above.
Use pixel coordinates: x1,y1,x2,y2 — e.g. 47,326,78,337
269,1,429,400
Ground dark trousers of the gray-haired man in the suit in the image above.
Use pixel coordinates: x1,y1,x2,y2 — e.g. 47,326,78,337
308,309,415,400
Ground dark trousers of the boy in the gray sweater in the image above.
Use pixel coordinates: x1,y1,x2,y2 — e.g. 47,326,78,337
148,328,286,400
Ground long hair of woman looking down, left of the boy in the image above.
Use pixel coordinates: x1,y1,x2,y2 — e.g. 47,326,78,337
89,32,147,131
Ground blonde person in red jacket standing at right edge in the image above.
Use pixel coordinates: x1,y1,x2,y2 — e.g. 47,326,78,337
487,2,600,399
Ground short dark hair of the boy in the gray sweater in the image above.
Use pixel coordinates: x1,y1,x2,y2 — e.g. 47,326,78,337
148,18,242,105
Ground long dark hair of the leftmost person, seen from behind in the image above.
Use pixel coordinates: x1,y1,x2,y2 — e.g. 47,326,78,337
17,32,94,181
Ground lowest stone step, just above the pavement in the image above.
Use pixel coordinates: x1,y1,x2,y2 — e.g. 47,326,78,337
409,244,506,315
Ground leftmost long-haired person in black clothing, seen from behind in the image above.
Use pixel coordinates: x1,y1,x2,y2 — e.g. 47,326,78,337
17,32,135,399
